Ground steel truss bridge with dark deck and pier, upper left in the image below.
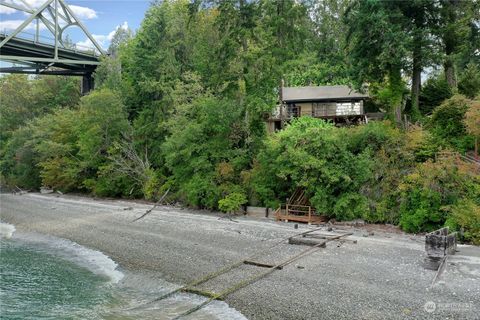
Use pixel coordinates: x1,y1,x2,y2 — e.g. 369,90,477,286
0,0,105,94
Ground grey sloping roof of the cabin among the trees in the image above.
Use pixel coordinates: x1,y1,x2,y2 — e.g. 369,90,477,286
282,86,368,102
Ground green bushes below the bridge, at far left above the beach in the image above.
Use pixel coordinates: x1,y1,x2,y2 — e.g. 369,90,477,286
2,90,128,195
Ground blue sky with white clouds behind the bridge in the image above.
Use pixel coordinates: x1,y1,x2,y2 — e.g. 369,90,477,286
0,0,150,49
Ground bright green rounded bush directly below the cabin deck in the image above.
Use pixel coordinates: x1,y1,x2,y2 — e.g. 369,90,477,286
256,117,373,219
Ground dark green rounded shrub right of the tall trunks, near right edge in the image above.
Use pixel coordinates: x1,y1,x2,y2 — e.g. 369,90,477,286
428,95,474,152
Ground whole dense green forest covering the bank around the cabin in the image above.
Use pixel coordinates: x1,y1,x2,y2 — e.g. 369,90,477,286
0,0,480,243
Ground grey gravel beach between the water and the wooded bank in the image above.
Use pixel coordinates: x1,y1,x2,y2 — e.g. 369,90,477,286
0,193,480,319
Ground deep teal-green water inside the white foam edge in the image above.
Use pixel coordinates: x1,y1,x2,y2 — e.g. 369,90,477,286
0,240,114,319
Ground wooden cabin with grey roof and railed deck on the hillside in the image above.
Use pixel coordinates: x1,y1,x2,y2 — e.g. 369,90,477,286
268,85,368,132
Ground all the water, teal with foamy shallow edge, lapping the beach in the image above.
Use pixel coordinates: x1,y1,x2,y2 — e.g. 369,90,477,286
0,223,246,320
